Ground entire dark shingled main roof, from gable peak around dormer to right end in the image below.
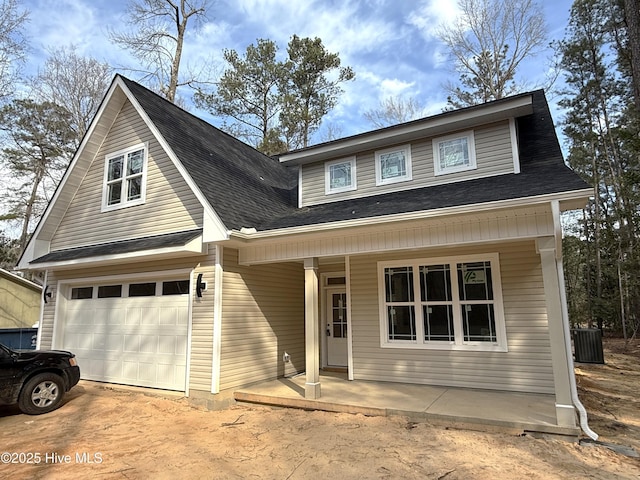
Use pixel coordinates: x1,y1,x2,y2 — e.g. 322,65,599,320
123,78,588,230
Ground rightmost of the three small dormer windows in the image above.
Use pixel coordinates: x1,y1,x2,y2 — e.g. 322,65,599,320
433,131,476,175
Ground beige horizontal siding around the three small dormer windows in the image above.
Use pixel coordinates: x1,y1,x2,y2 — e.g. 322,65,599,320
302,121,513,206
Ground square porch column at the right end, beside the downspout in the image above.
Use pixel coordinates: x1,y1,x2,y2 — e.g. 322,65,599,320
536,237,576,427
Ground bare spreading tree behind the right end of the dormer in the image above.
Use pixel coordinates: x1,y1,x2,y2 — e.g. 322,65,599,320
438,0,546,108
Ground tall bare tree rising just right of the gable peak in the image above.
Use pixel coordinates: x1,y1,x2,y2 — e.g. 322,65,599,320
109,0,209,102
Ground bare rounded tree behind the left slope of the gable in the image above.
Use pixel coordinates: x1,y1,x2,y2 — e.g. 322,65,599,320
31,46,112,142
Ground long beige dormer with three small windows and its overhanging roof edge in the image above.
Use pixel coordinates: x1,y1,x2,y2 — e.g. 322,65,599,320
280,93,533,207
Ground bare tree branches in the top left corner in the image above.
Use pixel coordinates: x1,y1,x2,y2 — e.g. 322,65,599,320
0,0,29,100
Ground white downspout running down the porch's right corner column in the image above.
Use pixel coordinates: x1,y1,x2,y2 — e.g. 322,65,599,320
551,200,598,441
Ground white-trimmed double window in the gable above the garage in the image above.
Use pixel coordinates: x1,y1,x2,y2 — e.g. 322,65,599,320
102,144,147,211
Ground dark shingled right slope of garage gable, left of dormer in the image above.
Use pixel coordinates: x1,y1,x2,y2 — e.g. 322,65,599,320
123,78,297,229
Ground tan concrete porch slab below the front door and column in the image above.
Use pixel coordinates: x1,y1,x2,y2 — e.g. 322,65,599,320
234,372,580,440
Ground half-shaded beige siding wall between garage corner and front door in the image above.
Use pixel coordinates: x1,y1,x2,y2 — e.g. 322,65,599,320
220,248,305,390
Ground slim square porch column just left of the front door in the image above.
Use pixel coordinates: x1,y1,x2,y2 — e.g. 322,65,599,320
304,258,320,399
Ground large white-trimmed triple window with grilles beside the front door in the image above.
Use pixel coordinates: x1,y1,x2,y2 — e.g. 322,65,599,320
378,254,507,351
